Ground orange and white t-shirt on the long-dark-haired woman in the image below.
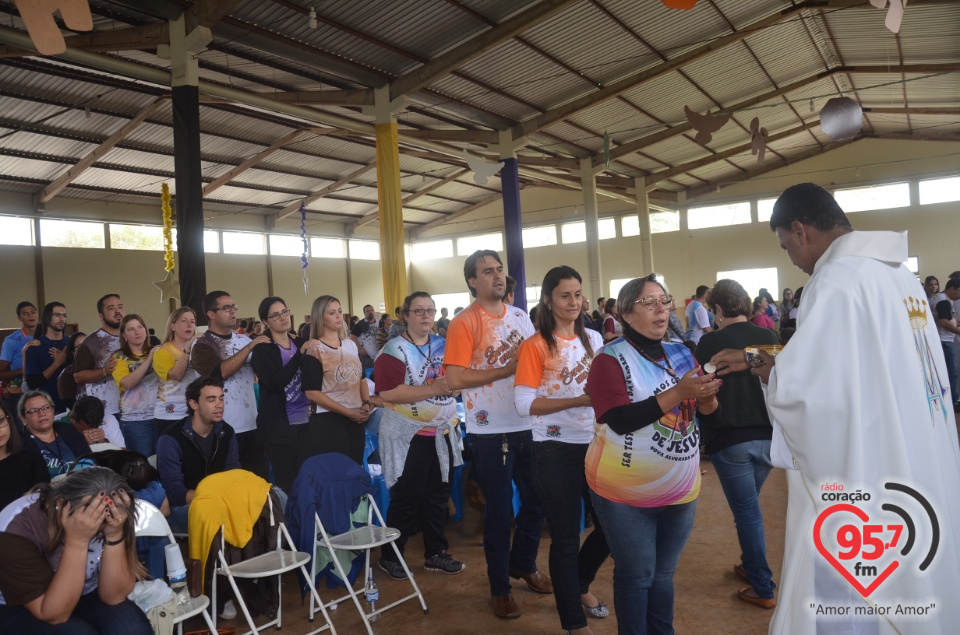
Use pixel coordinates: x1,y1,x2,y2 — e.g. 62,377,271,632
515,329,603,443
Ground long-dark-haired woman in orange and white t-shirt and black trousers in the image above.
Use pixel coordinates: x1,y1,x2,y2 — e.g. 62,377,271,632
514,266,610,633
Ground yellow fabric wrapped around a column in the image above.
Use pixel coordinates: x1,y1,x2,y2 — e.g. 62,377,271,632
374,123,407,315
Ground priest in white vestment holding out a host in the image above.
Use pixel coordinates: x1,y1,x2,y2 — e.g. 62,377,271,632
711,183,960,635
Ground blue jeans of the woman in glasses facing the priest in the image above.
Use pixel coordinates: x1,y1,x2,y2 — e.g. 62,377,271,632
591,492,697,635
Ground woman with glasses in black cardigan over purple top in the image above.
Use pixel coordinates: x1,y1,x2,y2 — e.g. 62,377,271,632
250,296,310,493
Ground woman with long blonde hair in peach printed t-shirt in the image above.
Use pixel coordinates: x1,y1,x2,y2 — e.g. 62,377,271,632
300,295,373,463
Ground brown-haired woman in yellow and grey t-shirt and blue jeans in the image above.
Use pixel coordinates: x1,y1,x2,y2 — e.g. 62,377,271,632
113,313,160,456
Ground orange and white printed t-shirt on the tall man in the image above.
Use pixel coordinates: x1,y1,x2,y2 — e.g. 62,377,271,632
443,302,535,434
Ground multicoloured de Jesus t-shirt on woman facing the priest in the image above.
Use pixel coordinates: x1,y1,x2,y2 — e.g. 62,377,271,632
586,338,700,507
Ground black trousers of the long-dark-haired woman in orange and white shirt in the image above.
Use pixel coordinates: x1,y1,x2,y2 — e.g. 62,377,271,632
533,441,610,631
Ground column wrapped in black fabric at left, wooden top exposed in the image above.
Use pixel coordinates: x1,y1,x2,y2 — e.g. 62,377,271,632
169,16,211,325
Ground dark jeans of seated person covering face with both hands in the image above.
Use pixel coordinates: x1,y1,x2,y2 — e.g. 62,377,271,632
0,590,153,635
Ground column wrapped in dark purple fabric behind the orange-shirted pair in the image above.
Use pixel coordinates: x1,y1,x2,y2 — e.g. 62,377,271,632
499,130,536,311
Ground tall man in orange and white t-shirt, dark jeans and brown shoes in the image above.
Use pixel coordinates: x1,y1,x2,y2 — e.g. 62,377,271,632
443,250,553,619
